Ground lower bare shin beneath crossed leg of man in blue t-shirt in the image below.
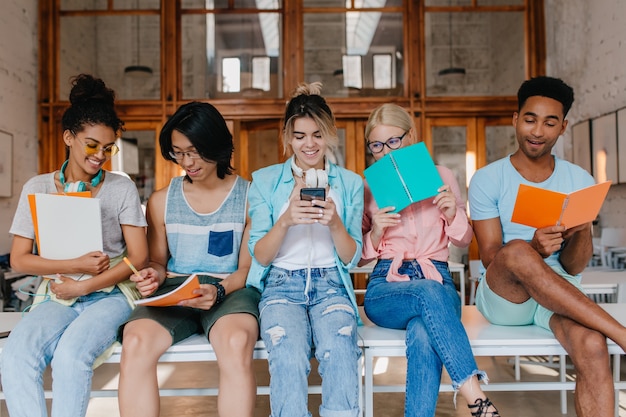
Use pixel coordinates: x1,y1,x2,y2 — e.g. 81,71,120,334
550,314,615,417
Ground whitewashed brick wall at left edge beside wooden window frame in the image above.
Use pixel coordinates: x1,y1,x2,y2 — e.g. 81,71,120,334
0,0,38,254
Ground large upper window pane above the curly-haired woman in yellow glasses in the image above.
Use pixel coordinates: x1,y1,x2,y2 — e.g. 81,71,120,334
59,15,161,100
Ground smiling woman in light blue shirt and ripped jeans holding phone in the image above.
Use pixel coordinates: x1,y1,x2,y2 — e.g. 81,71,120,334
248,83,363,417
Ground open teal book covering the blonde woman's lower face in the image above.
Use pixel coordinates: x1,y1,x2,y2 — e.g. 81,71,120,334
364,142,443,213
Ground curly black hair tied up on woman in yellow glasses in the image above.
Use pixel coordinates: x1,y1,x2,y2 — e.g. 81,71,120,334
61,74,124,134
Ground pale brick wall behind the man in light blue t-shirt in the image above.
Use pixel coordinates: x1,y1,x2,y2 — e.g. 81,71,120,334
545,0,626,227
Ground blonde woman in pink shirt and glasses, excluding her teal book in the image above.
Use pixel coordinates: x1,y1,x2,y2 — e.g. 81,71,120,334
361,104,499,417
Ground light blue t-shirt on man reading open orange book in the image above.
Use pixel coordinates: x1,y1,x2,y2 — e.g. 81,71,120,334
469,155,595,266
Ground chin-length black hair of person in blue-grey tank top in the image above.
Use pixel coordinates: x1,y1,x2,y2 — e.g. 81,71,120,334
159,101,235,182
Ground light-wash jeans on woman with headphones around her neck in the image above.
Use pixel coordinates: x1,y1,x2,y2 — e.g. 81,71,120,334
0,288,131,417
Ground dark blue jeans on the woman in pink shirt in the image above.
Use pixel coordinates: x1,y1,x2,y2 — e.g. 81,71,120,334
364,259,486,417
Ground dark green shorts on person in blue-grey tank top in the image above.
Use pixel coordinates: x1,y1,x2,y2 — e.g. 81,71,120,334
117,275,261,344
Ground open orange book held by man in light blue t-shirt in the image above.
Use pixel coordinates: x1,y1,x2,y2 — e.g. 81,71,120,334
511,181,611,229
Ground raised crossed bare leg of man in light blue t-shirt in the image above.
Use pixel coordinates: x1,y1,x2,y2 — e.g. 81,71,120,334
486,240,626,351
